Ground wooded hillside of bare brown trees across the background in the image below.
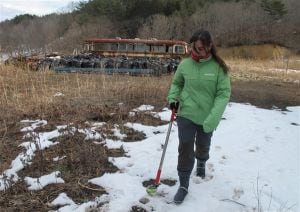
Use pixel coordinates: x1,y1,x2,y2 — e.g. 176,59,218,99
0,0,300,53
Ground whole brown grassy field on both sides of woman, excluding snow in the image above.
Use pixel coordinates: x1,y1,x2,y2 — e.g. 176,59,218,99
0,56,300,211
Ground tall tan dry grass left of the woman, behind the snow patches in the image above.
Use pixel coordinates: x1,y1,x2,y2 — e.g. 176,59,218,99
0,65,171,194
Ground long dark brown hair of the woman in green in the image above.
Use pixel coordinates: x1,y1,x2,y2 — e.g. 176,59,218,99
190,30,229,74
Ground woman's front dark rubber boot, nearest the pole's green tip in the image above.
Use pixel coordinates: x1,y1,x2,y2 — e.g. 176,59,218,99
174,171,191,204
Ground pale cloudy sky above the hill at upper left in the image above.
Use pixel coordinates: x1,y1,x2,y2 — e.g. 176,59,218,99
0,0,87,21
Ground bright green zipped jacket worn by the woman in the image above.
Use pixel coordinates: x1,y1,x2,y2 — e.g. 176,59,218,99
168,57,231,133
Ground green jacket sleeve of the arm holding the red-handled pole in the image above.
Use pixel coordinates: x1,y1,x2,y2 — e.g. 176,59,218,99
167,63,184,103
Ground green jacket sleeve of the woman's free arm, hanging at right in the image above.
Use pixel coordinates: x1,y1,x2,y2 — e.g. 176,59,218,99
203,70,231,133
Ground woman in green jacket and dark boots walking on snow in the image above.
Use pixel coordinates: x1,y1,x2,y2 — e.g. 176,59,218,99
168,30,231,204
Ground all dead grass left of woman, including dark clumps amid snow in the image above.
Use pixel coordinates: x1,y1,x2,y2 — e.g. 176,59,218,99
0,66,171,211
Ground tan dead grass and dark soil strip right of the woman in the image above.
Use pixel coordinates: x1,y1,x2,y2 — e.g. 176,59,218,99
226,56,300,109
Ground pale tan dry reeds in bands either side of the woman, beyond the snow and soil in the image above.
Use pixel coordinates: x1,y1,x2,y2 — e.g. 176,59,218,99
0,55,300,126
